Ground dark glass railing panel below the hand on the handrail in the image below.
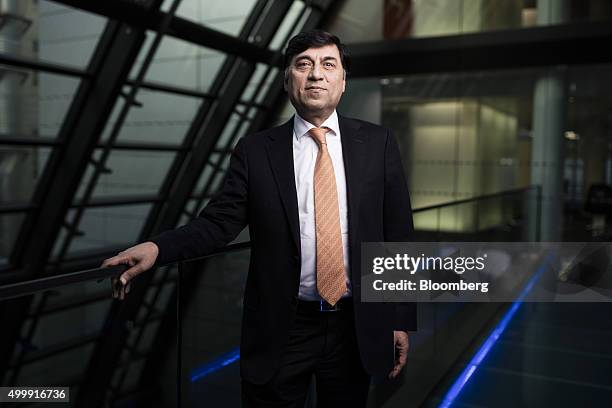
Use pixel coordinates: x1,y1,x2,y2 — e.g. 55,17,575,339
0,265,178,407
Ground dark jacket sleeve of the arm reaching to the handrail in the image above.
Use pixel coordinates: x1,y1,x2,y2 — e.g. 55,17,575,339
150,139,248,265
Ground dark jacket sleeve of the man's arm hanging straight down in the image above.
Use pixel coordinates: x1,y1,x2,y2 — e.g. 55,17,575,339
383,131,417,331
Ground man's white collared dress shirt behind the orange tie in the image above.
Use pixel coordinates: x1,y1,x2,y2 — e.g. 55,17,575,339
293,110,351,300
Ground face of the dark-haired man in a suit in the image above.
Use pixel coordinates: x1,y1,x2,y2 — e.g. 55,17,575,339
285,44,346,119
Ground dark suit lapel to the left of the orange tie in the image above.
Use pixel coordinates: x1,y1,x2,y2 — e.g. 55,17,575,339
267,118,300,253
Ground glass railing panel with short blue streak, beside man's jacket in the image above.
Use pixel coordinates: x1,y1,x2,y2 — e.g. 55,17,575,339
180,249,250,408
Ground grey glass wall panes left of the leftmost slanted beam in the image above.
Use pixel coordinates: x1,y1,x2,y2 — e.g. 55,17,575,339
0,0,107,267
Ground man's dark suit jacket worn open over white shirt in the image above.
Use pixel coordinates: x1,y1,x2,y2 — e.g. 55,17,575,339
152,116,416,384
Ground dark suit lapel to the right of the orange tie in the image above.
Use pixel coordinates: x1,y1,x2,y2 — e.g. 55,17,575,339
338,115,366,253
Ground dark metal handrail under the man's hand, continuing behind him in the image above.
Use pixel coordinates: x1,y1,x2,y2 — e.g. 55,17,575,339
0,186,538,300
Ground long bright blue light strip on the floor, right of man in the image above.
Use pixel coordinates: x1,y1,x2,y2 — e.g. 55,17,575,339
439,254,552,408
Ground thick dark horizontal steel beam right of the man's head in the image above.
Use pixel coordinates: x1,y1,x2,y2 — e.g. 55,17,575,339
349,21,612,78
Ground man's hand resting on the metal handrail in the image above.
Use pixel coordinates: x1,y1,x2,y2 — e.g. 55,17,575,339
101,241,159,300
